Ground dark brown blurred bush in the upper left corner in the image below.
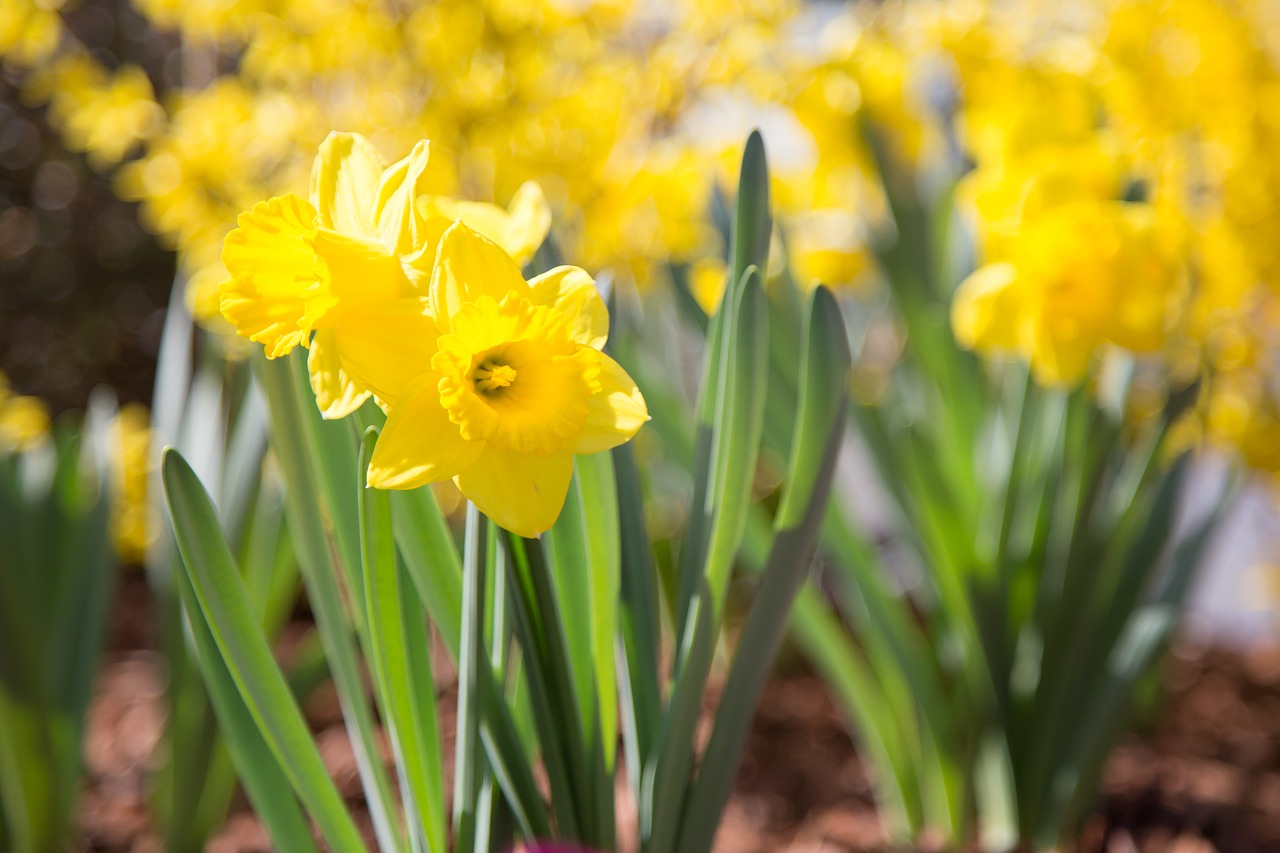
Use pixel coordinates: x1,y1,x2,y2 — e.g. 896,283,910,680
0,1,175,411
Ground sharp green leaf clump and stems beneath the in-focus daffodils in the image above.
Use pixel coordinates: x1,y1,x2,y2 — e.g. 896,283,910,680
164,134,850,853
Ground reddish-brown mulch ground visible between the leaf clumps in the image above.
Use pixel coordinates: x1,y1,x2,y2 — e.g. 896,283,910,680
79,579,1280,853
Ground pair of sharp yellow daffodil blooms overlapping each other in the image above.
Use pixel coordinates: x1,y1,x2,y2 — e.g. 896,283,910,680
219,133,649,537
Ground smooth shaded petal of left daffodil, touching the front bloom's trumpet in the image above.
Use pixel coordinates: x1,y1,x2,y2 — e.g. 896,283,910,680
333,298,440,405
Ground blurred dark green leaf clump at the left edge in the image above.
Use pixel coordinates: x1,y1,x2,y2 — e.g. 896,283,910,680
0,394,115,853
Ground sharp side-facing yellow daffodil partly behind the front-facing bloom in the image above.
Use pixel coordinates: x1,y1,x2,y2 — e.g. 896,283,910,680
219,133,550,418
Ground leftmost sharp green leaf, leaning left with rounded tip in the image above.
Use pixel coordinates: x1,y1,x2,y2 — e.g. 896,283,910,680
163,450,365,850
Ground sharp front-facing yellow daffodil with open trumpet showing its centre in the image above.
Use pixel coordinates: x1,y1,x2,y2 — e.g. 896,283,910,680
351,222,649,537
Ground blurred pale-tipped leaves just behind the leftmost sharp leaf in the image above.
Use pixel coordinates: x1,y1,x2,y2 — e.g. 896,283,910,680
146,286,307,853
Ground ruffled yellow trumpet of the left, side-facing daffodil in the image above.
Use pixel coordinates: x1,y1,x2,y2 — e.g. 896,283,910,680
219,196,325,359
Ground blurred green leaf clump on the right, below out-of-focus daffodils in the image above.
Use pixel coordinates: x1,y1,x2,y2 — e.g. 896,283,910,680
795,126,1229,849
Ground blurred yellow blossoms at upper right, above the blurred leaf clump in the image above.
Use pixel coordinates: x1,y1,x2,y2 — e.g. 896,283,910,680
870,0,1280,471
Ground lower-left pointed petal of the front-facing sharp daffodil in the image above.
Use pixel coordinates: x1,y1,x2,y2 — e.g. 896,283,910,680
369,374,485,489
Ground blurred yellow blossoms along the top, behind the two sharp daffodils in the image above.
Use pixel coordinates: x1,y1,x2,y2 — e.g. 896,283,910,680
0,0,920,328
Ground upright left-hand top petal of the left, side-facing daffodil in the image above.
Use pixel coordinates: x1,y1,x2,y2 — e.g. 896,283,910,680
311,133,387,240
